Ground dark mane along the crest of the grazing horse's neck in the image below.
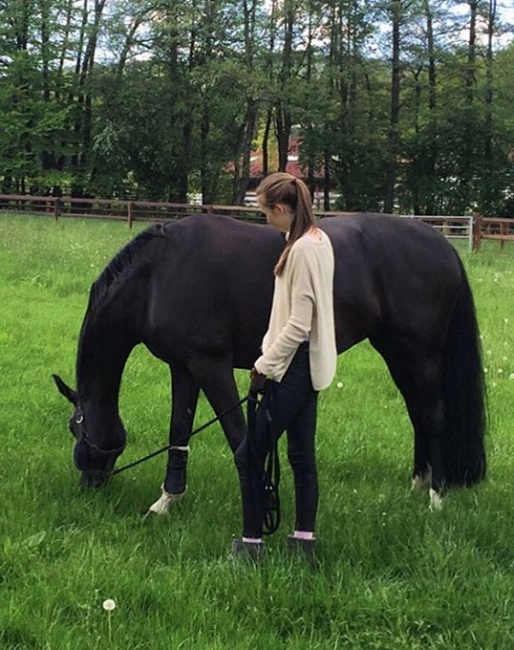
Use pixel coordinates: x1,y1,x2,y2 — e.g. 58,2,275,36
88,224,165,311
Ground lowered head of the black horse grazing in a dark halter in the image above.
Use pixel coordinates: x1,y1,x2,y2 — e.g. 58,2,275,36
52,375,126,487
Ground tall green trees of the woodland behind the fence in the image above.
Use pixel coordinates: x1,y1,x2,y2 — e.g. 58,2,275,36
0,0,514,216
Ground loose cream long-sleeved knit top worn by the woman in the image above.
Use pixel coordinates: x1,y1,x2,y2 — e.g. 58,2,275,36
254,230,337,390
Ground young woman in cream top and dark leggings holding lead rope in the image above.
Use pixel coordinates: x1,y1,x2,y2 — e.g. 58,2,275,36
232,172,337,559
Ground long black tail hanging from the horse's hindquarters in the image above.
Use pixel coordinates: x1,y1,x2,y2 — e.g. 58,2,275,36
443,260,486,485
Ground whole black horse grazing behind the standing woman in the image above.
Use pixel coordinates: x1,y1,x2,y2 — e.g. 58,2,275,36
54,214,486,512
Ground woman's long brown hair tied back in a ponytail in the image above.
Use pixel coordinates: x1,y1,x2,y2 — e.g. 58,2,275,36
257,172,316,275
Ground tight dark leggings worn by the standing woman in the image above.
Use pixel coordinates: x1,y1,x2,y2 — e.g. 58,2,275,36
235,343,318,537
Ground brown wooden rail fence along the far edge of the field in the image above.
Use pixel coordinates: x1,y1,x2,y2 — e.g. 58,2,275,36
0,194,514,251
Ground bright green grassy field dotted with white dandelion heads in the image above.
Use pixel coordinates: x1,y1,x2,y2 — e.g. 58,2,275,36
0,215,514,650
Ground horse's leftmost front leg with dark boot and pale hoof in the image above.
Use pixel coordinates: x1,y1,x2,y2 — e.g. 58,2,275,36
148,363,199,515
